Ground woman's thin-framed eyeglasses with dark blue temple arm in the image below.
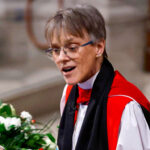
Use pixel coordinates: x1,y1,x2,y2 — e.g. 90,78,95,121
45,41,94,58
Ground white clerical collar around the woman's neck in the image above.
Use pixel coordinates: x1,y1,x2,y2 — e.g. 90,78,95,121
78,72,98,89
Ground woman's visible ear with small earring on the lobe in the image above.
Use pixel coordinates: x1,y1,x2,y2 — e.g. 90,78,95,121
96,40,105,57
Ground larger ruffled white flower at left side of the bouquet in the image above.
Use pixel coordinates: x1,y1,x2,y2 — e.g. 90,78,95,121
4,117,21,130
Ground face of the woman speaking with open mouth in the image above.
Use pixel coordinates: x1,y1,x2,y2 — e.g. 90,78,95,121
50,32,104,85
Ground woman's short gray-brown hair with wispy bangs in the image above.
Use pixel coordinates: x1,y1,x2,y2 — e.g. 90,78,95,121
45,5,107,57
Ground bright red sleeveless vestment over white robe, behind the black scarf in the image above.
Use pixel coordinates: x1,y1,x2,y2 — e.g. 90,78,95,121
66,71,150,150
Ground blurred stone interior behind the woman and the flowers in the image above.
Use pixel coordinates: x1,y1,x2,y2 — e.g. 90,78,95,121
0,0,150,137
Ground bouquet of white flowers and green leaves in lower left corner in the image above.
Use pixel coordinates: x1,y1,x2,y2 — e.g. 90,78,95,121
0,102,57,150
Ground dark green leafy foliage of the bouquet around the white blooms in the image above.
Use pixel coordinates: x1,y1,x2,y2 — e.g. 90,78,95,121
0,101,55,150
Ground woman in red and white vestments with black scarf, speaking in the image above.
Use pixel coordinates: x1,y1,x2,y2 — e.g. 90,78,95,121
45,5,150,150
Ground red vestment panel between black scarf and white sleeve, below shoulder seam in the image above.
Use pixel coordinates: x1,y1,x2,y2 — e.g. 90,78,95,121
107,96,131,150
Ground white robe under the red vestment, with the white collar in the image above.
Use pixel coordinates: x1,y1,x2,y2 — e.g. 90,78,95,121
60,73,150,150
